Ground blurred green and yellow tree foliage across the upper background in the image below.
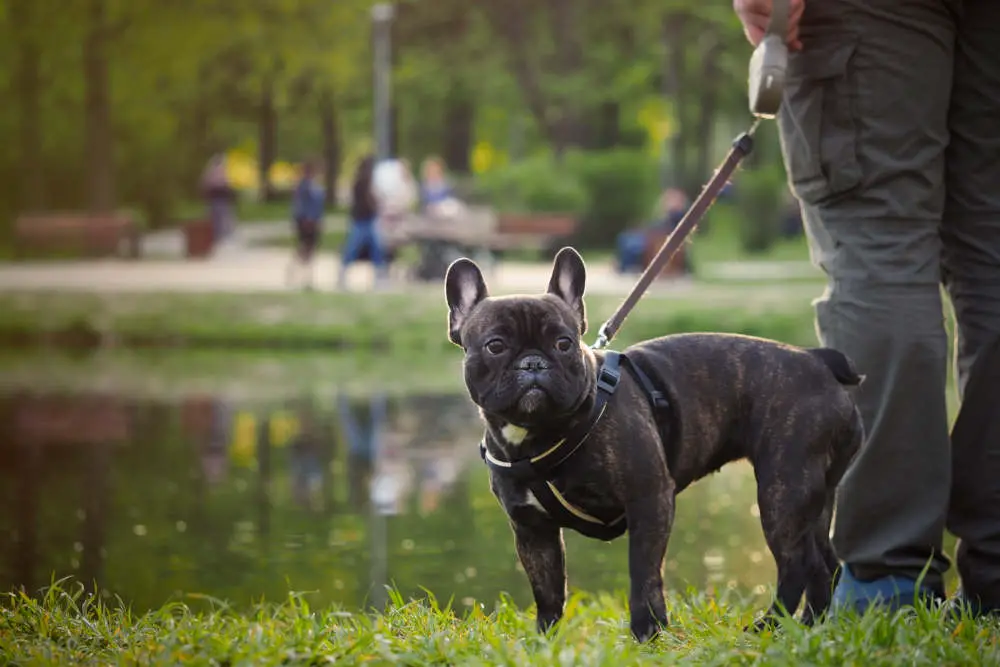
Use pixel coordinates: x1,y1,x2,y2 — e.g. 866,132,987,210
0,0,772,230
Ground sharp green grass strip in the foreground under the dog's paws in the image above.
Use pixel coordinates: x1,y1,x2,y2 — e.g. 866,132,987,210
0,584,1000,667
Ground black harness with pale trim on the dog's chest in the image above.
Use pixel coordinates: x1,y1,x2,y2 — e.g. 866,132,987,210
479,351,670,542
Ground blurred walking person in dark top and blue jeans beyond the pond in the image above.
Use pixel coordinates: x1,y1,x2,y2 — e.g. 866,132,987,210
337,155,388,289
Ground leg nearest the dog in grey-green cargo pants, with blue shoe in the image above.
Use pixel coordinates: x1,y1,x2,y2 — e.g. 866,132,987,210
778,0,954,610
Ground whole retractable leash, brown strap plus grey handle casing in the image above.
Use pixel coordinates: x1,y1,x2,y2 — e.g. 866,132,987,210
592,0,789,350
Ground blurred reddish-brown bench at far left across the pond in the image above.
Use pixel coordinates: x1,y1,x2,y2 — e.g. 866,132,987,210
13,212,142,259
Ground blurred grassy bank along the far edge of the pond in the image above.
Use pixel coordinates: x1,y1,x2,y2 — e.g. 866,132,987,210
0,285,828,352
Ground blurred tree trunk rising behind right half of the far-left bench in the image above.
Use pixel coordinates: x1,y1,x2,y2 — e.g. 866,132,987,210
83,0,115,213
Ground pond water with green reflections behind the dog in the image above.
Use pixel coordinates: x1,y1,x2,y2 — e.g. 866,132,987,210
0,354,774,610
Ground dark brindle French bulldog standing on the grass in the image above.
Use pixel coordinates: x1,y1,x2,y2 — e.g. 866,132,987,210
445,248,864,641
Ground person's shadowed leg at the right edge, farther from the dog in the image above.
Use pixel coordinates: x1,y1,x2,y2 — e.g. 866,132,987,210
941,0,1000,609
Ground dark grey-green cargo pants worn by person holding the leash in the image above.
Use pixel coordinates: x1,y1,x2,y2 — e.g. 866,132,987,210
777,0,1000,605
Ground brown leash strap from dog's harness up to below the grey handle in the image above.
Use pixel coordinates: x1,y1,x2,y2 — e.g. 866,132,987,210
593,119,760,350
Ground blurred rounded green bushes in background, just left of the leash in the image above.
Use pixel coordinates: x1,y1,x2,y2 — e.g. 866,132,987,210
478,149,658,247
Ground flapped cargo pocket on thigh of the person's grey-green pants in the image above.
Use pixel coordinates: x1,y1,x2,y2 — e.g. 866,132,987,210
777,37,862,205
